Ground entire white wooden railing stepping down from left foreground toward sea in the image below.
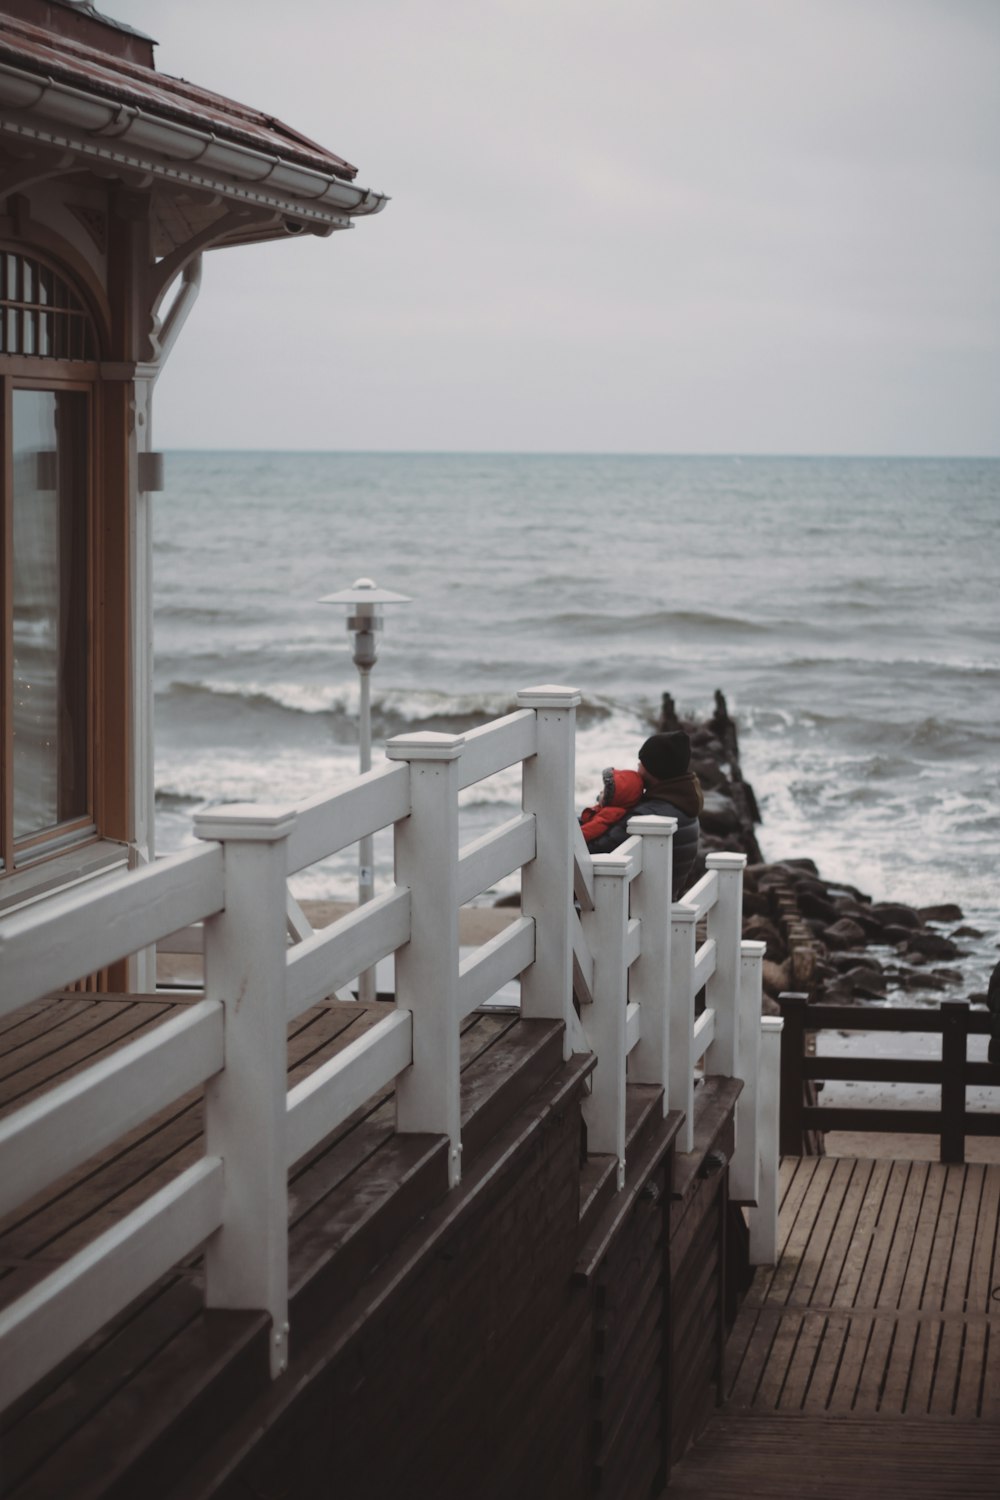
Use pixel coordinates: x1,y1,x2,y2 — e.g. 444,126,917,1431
0,687,777,1407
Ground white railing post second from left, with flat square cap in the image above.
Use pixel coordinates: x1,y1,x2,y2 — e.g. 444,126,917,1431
385,732,465,1187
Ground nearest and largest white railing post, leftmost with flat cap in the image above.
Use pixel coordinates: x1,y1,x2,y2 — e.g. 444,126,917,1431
195,806,295,1379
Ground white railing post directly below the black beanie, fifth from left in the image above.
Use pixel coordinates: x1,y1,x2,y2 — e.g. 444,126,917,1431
628,818,678,1115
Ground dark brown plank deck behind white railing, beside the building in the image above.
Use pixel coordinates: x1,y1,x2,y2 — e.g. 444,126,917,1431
0,993,562,1500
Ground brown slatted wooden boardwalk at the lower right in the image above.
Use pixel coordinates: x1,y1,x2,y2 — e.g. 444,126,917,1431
667,1157,1000,1500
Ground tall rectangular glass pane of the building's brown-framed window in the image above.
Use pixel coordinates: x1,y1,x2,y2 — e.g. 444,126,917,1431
12,390,88,840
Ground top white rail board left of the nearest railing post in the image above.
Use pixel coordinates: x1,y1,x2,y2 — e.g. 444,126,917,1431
0,848,225,1016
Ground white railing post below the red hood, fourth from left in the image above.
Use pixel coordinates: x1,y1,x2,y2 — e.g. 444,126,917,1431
583,854,628,1188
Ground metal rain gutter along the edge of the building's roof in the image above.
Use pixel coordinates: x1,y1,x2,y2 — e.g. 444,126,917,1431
0,62,388,228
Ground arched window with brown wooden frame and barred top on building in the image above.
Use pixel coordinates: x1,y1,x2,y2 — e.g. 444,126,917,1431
0,249,97,873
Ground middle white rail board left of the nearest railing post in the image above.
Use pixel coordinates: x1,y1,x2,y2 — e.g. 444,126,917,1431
0,1001,223,1214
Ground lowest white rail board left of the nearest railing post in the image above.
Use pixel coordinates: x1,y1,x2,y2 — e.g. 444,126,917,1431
0,1157,223,1409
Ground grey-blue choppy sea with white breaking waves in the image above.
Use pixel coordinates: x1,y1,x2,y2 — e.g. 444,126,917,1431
154,452,1000,990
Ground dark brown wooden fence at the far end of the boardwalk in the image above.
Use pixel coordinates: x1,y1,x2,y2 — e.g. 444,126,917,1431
780,995,1000,1161
